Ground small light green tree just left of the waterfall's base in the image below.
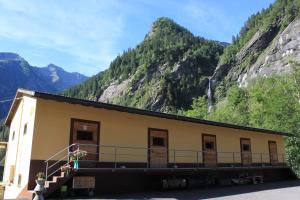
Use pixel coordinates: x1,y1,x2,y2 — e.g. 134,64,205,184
182,96,208,119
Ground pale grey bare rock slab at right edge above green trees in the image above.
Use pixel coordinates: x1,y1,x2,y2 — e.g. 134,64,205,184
238,18,300,86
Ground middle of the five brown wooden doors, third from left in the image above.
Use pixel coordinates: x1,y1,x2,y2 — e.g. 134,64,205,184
202,135,217,167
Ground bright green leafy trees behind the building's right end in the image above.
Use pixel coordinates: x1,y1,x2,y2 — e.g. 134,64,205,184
206,68,300,175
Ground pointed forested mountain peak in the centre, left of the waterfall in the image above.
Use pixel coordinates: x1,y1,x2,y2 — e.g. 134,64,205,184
64,18,226,112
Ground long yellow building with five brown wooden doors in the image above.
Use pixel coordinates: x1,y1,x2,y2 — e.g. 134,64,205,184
4,89,298,199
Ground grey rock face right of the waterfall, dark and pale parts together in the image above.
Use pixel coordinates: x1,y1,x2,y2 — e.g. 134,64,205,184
211,17,300,97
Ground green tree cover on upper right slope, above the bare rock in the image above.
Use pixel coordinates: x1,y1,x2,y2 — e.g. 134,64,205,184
220,0,300,88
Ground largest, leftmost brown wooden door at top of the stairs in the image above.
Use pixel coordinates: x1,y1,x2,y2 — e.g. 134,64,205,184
70,119,100,161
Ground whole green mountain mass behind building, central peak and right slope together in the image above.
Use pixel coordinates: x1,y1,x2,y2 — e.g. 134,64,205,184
63,0,300,175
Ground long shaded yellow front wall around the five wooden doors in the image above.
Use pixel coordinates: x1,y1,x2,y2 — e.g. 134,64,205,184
32,99,284,163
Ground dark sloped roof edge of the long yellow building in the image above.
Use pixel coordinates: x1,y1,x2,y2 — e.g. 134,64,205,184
5,89,292,136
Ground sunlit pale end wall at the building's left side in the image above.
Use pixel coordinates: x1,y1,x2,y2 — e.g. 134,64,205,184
3,96,36,199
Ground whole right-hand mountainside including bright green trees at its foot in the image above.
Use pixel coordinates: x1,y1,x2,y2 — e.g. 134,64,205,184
183,0,300,176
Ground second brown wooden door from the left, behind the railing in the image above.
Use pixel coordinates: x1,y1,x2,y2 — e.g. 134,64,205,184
148,129,168,168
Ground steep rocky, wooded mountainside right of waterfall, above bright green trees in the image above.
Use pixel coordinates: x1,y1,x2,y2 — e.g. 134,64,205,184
211,0,300,99
